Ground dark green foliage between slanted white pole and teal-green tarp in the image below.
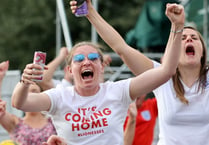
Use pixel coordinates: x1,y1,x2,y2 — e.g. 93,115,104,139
66,0,145,51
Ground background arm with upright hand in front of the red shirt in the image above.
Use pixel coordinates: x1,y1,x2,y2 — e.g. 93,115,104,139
124,102,137,145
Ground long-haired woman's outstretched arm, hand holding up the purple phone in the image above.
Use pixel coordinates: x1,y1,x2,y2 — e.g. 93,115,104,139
70,0,153,75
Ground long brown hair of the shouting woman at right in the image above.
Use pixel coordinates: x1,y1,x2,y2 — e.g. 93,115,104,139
172,26,208,104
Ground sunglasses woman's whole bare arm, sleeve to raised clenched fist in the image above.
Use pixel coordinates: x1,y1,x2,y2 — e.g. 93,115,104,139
130,4,185,99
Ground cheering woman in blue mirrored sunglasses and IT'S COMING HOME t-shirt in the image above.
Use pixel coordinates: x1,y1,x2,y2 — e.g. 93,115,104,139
12,5,184,145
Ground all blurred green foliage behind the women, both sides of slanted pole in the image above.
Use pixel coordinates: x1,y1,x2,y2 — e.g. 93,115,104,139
0,0,144,70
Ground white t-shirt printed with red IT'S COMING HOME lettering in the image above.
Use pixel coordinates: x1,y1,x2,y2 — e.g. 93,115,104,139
45,79,132,145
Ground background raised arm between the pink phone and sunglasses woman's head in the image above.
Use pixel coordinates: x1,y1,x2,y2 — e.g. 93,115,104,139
39,47,68,90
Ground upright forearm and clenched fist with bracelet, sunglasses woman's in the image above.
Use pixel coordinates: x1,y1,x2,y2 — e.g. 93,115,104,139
162,3,185,74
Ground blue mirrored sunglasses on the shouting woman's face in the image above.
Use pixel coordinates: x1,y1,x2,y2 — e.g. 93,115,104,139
73,53,100,62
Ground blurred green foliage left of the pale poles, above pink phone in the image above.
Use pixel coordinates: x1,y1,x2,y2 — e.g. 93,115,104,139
0,0,56,70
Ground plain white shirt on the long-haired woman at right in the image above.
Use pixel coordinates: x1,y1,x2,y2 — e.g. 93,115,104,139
154,63,209,145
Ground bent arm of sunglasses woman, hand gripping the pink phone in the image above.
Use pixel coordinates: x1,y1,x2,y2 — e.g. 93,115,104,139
12,63,51,112
